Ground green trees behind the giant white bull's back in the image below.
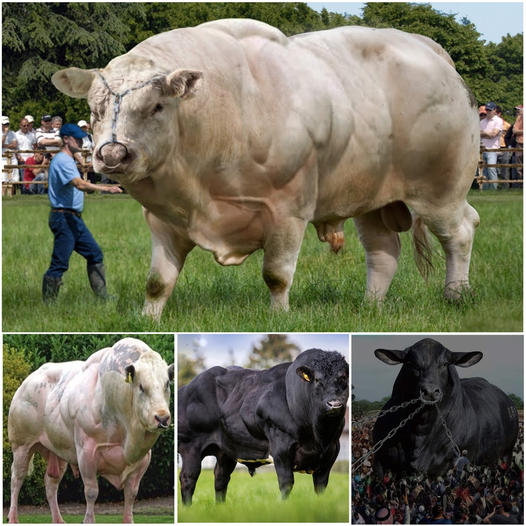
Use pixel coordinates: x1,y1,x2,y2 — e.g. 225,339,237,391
2,2,523,122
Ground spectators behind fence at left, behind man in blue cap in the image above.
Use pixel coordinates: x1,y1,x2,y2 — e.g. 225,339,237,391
2,114,96,194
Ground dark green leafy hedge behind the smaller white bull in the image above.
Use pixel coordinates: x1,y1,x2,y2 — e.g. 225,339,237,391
3,334,174,504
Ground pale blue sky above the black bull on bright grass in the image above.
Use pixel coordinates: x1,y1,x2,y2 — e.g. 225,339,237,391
177,333,349,367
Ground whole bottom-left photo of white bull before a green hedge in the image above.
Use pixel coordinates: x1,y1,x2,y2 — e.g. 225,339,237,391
3,333,175,523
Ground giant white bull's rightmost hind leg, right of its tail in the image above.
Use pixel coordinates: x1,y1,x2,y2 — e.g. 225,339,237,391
417,201,480,301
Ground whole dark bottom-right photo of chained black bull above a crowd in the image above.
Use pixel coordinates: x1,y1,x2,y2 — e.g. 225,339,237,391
351,334,524,524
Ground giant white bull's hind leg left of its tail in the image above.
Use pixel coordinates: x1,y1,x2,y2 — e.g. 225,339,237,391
354,210,400,301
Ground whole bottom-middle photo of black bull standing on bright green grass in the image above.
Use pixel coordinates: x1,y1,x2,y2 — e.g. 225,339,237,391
177,333,349,523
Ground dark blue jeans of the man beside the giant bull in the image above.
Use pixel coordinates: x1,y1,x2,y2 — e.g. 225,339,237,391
46,211,103,278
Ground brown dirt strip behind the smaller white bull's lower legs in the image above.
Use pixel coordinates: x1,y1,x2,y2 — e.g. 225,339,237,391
12,497,174,515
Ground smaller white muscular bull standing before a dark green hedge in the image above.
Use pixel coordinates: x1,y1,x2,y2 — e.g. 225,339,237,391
8,338,174,523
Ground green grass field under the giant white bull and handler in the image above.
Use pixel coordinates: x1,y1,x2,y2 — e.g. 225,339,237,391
2,190,523,332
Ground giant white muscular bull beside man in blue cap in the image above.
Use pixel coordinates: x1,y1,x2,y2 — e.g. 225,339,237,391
52,19,479,318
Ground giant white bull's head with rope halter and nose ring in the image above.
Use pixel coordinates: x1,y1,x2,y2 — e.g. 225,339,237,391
51,55,202,184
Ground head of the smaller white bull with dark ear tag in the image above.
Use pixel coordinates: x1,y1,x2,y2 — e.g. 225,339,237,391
125,351,174,432
